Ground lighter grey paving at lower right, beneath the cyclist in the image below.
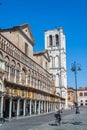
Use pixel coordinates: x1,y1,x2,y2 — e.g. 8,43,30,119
28,110,87,130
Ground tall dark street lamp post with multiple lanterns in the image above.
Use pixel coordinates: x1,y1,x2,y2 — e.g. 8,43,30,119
71,61,81,114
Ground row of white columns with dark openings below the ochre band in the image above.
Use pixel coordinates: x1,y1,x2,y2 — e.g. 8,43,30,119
0,96,57,118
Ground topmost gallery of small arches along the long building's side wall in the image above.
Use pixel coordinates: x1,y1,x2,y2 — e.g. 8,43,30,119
0,34,50,77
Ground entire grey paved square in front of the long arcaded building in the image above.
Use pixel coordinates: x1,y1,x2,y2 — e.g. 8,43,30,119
0,109,87,130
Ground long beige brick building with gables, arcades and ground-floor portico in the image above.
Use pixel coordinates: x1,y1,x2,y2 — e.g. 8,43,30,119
0,24,59,118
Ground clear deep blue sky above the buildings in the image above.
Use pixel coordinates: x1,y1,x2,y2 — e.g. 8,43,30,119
0,0,87,88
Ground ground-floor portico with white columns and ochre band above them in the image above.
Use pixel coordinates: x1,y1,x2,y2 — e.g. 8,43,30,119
0,78,59,118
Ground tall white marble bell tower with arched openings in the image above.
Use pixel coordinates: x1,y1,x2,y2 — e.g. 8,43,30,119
45,28,67,108
